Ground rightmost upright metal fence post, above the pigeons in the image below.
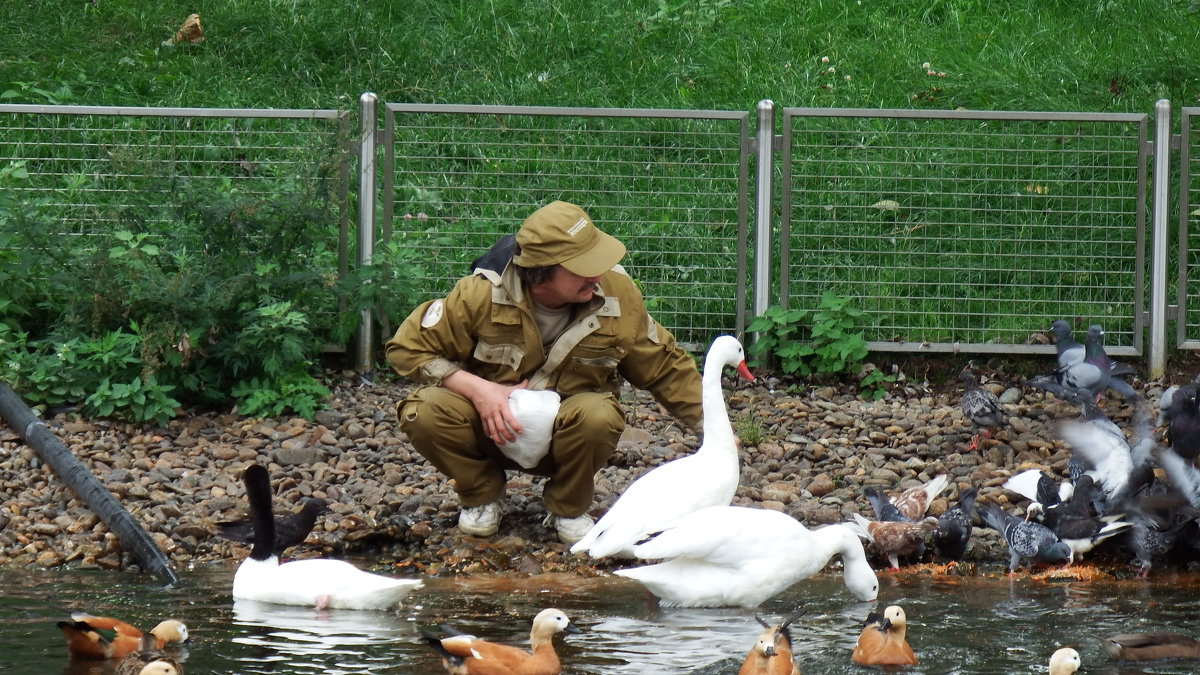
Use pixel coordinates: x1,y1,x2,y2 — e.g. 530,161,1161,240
1148,98,1171,380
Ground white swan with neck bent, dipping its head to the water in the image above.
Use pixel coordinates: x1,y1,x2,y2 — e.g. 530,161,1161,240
614,506,878,608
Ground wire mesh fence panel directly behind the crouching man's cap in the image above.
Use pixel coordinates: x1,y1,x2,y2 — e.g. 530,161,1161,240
382,103,749,347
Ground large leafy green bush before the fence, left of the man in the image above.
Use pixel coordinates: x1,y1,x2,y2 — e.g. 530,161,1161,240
0,165,418,423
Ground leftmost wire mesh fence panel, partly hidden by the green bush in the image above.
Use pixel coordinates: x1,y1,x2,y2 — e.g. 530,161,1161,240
0,104,353,341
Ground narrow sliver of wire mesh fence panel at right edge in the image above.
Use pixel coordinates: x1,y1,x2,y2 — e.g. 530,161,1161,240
1175,108,1200,350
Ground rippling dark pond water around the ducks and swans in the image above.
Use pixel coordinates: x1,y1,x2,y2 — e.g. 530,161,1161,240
0,561,1200,675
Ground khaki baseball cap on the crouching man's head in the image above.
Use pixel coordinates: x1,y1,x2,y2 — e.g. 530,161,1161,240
512,202,625,276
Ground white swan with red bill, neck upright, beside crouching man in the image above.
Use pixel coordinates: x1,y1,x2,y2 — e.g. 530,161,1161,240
571,335,754,558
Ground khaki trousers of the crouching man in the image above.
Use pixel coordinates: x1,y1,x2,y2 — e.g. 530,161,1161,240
396,387,625,518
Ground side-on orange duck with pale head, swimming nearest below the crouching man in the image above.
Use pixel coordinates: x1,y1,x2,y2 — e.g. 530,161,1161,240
421,609,580,675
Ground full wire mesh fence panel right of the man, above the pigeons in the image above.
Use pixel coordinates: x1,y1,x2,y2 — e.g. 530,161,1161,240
780,108,1147,354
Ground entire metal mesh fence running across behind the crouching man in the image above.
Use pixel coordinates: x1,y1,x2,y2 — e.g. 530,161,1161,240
0,95,1200,372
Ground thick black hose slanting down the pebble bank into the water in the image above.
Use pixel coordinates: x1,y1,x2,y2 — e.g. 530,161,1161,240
0,382,179,585
